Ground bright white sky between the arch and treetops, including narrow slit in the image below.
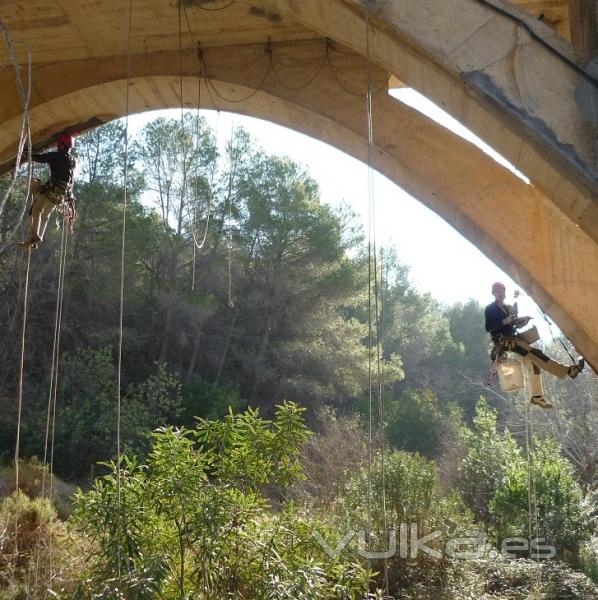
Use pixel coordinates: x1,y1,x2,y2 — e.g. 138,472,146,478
129,89,558,340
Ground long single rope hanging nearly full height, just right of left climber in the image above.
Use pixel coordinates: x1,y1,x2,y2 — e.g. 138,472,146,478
116,0,133,582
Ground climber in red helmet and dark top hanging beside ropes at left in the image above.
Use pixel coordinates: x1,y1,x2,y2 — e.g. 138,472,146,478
18,134,76,248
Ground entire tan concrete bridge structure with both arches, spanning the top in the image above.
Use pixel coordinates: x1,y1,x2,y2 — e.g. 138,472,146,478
0,0,598,367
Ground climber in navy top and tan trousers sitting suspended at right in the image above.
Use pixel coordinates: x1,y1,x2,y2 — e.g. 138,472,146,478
484,281,585,408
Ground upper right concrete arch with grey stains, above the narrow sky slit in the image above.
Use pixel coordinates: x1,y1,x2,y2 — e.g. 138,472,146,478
262,0,598,231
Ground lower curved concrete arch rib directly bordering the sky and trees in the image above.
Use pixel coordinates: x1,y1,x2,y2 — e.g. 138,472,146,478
0,40,598,366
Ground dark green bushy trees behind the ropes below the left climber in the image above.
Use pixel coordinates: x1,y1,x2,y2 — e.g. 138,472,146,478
24,348,182,477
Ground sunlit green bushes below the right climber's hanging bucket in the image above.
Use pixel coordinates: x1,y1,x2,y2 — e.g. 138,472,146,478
459,400,590,564
